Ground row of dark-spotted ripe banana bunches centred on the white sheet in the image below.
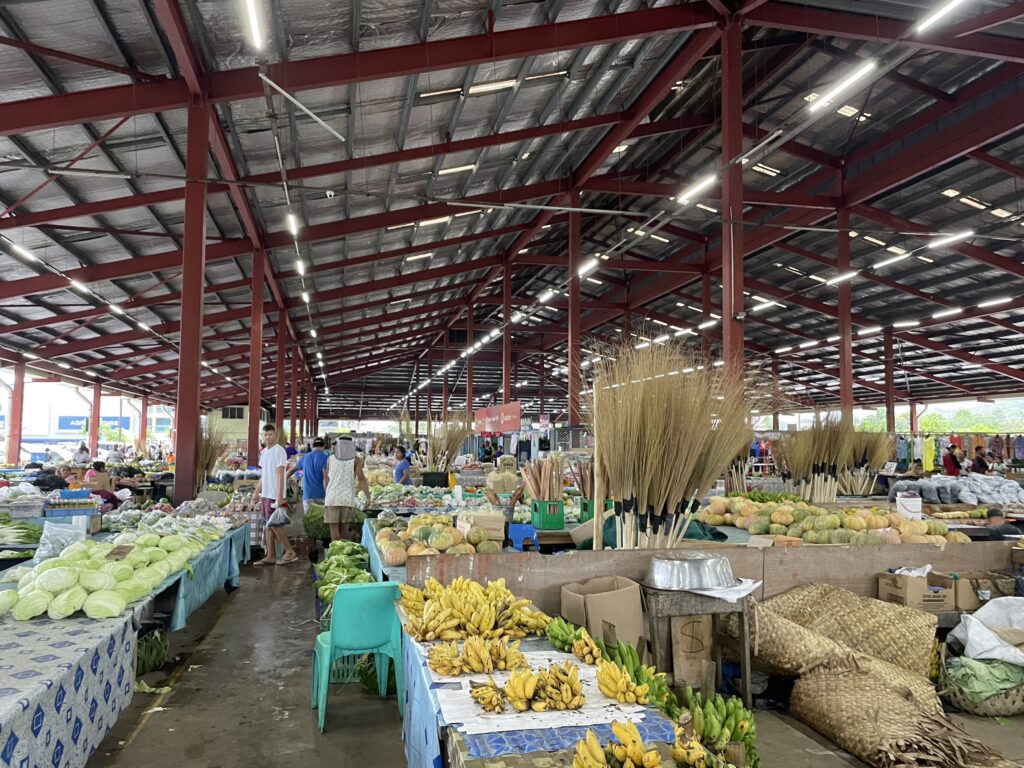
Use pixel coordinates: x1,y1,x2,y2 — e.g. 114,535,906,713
470,662,587,712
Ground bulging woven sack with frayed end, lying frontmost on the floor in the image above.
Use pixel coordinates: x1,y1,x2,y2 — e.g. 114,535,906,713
790,667,1011,768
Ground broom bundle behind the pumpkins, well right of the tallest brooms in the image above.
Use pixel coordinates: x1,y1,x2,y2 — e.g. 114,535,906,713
774,414,854,504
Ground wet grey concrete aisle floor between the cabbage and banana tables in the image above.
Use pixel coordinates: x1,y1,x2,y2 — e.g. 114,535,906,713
89,562,406,768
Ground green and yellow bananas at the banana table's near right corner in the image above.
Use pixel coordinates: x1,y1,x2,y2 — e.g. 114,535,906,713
672,686,761,768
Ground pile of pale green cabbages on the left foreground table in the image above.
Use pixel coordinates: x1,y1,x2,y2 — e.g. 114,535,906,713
0,532,206,622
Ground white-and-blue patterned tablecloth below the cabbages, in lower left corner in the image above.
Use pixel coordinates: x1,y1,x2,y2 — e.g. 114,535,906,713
0,612,137,768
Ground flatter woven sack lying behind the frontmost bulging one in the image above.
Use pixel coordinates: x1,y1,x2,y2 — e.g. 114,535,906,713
764,584,938,677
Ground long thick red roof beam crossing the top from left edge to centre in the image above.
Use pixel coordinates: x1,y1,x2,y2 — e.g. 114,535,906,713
0,3,717,135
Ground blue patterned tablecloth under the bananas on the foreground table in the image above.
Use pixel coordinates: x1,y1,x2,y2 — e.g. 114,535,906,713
401,634,676,768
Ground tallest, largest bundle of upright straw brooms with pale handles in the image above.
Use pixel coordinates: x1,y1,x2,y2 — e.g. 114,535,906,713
589,343,757,549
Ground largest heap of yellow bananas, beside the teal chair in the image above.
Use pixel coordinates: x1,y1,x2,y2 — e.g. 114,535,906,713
398,577,551,642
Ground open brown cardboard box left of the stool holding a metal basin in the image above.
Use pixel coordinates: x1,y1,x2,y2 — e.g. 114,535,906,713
561,575,646,645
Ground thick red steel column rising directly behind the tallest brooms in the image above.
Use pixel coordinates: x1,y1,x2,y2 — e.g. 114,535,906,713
721,17,743,376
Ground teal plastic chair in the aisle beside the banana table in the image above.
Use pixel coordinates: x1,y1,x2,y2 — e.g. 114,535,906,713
312,582,404,733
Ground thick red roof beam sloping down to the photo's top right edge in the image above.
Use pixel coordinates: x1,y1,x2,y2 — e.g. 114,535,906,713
744,2,1024,63
